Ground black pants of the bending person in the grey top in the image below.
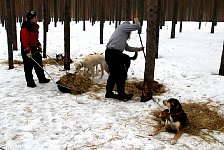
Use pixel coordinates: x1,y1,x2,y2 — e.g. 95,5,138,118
105,49,127,95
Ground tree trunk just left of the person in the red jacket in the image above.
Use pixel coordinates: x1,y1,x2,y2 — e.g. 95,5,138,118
5,0,14,69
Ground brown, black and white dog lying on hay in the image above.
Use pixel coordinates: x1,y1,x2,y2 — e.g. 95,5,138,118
153,98,187,144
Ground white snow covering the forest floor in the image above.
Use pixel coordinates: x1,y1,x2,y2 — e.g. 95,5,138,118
0,22,224,150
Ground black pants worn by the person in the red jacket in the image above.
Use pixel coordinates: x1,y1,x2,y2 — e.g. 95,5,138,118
21,48,45,84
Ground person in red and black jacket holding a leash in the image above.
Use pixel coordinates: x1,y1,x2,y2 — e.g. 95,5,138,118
20,10,50,88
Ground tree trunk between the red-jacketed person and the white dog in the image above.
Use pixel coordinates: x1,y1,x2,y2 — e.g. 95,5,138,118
64,0,71,70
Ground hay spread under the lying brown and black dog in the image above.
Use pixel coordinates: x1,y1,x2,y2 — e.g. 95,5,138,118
153,103,224,142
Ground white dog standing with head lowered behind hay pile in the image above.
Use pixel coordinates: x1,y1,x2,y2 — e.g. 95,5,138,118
75,53,109,80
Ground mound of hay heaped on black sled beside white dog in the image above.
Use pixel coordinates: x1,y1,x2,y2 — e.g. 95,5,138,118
58,73,92,95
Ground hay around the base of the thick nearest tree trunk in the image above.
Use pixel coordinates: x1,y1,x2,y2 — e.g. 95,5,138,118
126,81,166,97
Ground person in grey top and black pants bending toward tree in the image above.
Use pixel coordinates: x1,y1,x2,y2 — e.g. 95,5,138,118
105,18,144,101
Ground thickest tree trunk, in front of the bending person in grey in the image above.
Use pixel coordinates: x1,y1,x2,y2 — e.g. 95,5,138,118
141,0,158,102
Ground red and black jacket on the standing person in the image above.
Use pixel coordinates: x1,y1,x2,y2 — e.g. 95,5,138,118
20,21,41,53
